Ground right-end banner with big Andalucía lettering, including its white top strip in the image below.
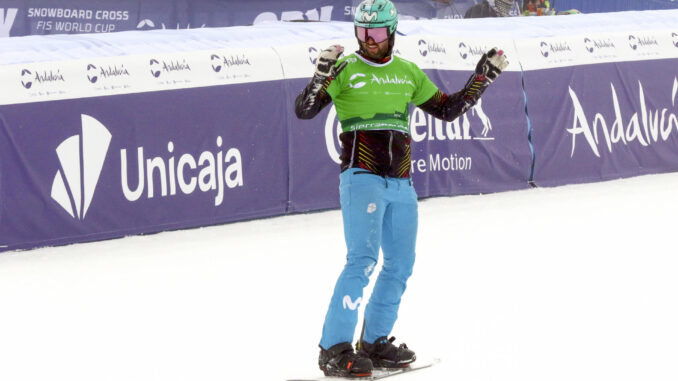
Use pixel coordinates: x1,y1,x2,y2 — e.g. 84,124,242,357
518,31,678,186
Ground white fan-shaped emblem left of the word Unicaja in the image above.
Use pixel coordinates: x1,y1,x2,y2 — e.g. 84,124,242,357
51,114,111,220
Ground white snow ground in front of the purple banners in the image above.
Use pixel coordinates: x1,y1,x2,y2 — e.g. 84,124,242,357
0,173,678,381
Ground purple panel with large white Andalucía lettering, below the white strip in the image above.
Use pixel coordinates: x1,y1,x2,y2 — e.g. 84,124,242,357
525,59,678,186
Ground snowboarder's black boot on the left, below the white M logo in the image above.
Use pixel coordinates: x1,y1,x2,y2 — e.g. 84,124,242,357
318,343,372,377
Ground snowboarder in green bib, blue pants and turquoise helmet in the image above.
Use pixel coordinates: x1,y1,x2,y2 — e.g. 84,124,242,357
295,0,508,377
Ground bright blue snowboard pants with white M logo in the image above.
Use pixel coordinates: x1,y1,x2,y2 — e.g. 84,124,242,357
320,168,417,349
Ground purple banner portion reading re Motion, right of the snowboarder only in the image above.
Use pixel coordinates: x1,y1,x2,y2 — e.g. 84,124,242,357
410,70,532,197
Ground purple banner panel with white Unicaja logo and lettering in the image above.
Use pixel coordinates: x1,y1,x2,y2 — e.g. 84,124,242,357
0,81,289,251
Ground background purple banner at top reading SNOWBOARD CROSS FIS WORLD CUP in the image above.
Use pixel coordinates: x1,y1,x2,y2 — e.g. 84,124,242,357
0,0,486,37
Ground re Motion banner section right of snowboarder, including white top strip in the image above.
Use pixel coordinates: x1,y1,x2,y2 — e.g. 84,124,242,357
398,34,532,197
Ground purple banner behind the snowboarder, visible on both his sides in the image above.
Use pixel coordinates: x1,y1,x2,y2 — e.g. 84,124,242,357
288,70,532,212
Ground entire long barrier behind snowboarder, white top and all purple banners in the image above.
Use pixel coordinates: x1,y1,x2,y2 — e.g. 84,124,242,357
0,11,678,251
